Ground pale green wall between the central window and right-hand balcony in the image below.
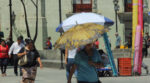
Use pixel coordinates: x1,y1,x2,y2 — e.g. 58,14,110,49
97,0,124,49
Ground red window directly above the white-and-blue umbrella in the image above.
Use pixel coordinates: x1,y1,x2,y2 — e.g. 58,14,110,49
73,0,92,13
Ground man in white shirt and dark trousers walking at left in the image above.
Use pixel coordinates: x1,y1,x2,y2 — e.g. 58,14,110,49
8,37,24,76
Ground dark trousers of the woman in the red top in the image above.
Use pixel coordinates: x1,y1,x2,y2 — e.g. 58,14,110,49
0,58,8,74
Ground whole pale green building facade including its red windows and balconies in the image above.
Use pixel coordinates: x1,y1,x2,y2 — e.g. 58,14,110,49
0,0,150,50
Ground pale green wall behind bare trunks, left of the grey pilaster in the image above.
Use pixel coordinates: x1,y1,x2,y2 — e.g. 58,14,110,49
0,0,43,49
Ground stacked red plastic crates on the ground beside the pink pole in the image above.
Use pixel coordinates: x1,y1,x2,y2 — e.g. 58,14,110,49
118,58,132,76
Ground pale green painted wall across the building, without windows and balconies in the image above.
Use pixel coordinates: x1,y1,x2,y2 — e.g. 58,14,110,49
0,0,150,50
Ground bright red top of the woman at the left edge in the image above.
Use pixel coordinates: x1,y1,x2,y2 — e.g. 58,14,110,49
0,45,9,58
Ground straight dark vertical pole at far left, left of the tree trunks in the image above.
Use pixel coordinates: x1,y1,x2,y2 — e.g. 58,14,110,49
9,0,13,41
